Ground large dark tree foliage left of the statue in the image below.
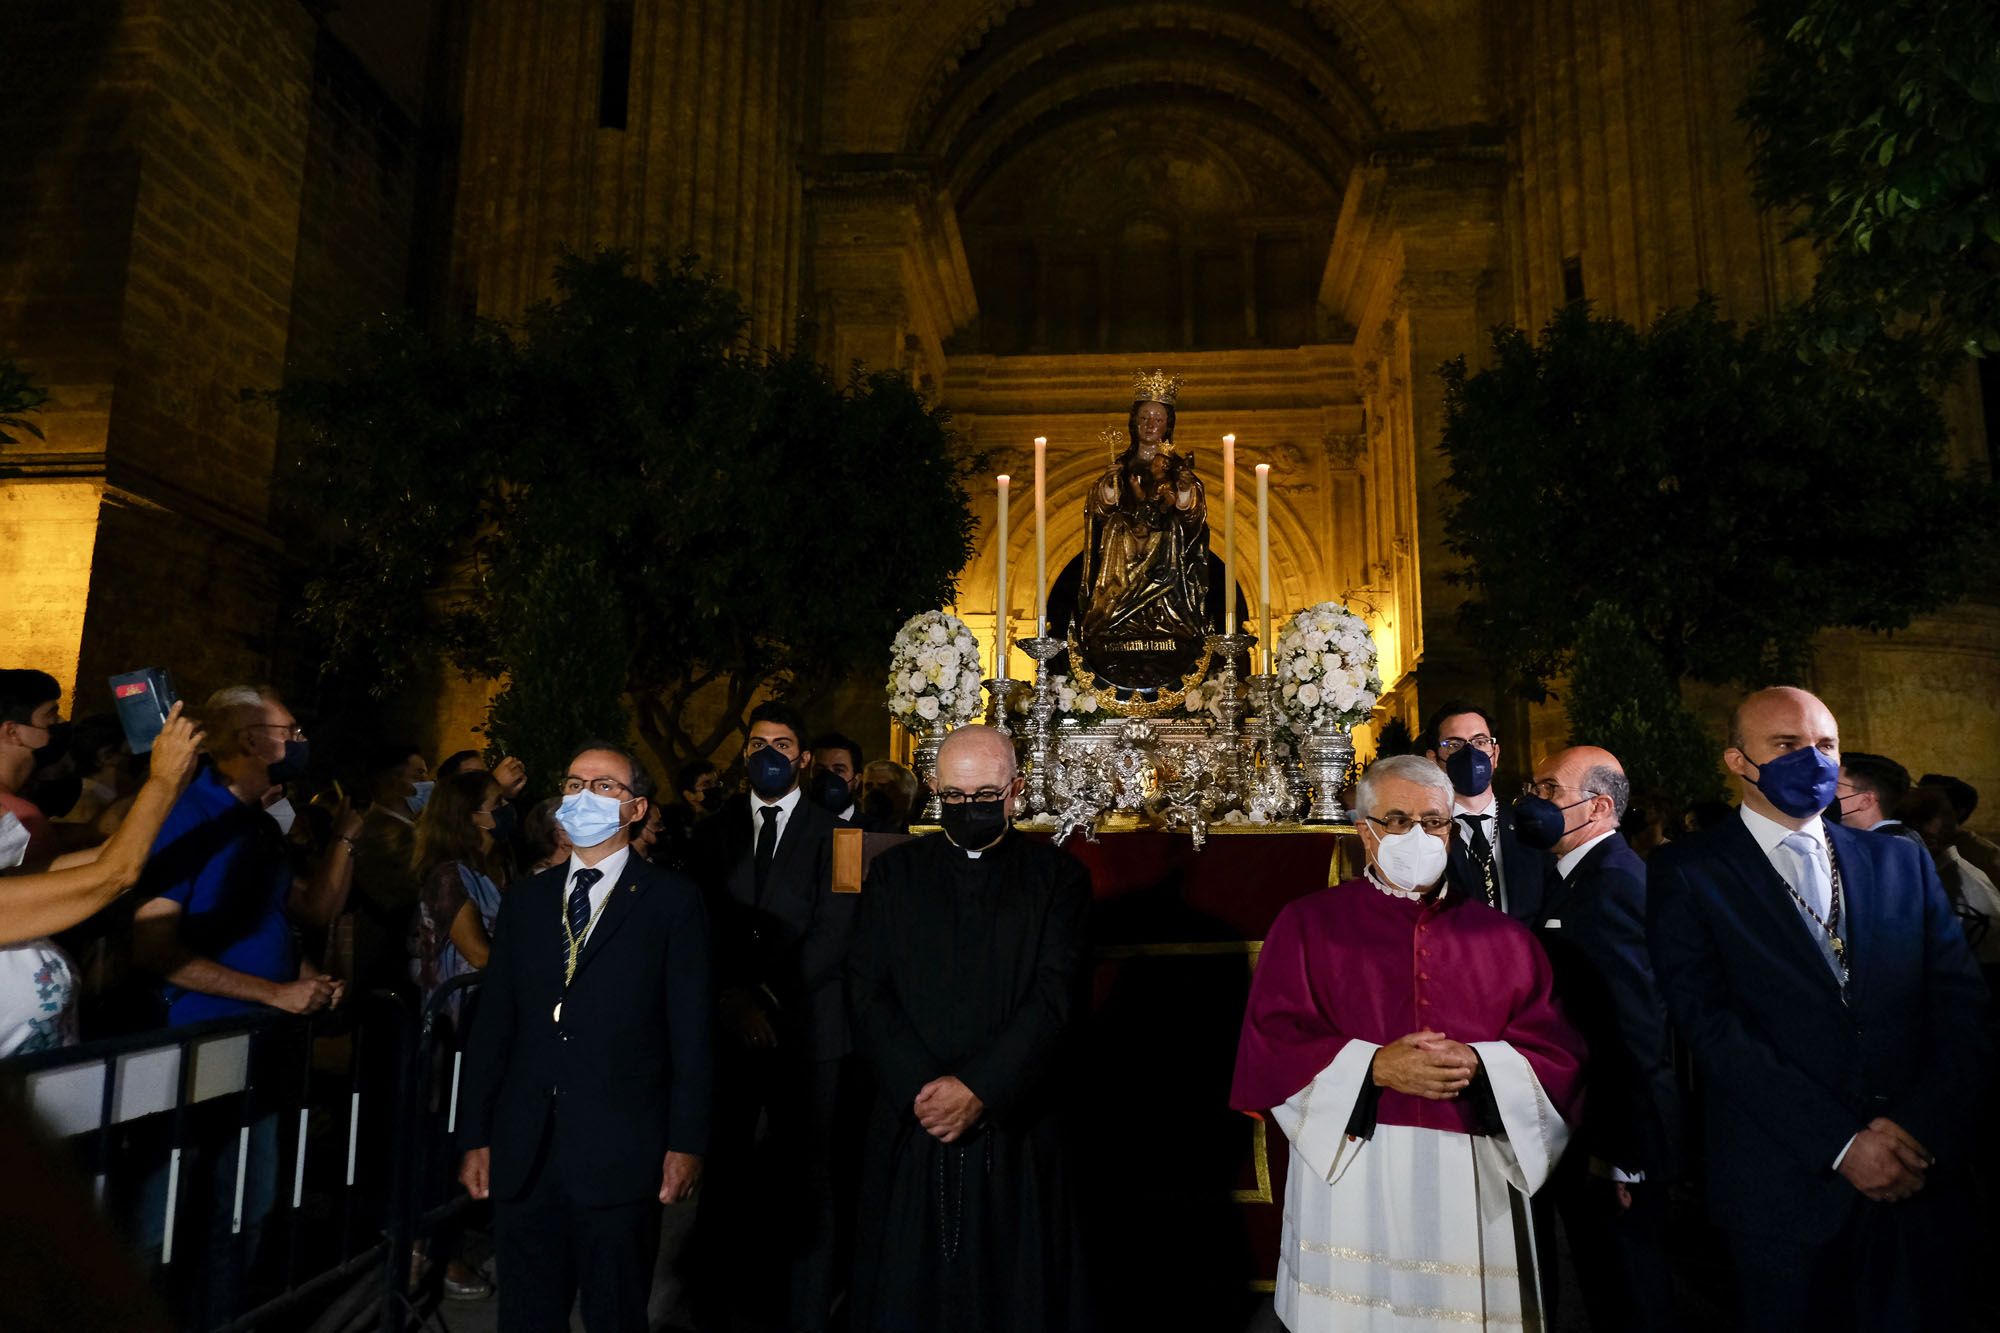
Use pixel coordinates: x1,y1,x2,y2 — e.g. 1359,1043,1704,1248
262,252,976,775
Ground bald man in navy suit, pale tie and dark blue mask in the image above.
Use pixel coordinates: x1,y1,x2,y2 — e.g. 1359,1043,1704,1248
1648,689,1990,1333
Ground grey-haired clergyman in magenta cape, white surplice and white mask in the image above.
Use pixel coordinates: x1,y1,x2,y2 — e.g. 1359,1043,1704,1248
1230,755,1584,1333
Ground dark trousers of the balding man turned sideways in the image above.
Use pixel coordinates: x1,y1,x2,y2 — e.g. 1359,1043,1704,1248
1548,1169,1678,1333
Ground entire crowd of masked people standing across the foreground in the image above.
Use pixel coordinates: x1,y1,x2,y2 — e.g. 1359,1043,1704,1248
0,671,2000,1333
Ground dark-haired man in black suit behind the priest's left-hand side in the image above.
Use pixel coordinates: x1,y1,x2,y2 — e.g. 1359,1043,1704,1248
694,703,854,1333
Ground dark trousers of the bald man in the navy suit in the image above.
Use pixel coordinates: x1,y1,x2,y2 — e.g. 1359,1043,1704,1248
1728,1169,1972,1333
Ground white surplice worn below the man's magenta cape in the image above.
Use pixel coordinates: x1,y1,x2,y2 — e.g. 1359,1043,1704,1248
1272,1041,1570,1333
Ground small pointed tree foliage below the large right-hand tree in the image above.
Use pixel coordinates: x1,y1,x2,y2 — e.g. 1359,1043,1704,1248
1566,600,1722,805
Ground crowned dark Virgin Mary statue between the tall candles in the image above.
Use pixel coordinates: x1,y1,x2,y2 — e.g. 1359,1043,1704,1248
1078,370,1210,689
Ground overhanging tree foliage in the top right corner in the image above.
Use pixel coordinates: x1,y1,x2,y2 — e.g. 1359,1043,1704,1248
1742,0,2000,362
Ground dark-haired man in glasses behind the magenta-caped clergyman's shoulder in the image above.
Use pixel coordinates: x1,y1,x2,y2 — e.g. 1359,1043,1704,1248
1424,699,1556,925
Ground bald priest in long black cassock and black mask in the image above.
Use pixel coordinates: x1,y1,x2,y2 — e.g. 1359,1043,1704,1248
848,727,1092,1333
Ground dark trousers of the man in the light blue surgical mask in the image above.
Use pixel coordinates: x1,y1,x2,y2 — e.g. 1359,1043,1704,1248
494,1147,660,1333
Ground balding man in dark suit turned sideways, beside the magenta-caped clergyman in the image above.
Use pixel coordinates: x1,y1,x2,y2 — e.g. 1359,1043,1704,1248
1520,747,1680,1333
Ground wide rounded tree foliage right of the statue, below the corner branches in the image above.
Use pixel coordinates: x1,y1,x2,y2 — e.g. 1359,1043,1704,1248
1442,300,1992,691
